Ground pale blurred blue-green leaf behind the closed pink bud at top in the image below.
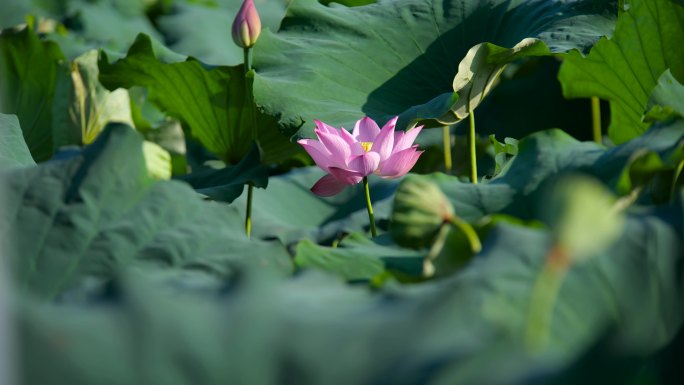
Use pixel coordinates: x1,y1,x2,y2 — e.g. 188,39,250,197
157,0,288,65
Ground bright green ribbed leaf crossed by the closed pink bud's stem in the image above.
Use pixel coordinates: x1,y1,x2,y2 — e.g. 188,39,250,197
99,35,302,164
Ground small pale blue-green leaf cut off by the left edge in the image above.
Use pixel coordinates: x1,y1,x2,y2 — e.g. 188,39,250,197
0,114,36,169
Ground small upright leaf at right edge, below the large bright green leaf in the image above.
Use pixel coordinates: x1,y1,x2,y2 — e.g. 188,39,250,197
645,69,684,121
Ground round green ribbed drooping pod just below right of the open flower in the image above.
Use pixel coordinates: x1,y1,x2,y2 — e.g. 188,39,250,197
390,177,454,248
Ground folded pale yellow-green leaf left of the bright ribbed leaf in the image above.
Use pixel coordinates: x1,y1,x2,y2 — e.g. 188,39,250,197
52,51,133,148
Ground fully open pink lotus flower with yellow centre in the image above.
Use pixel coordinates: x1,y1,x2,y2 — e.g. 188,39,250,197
297,117,423,197
